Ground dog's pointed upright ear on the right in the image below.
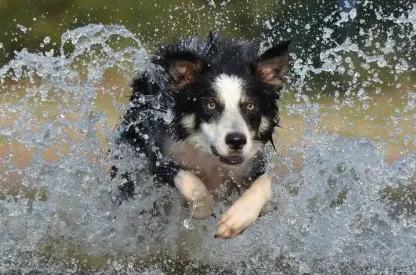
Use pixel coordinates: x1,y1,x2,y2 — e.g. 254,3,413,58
253,41,290,87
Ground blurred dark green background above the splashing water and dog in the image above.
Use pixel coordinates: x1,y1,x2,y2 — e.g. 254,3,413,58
0,0,414,69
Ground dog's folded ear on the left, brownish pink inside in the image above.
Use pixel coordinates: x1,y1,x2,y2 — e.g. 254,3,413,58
164,52,206,91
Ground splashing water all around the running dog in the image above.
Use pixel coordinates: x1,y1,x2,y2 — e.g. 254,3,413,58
0,1,416,274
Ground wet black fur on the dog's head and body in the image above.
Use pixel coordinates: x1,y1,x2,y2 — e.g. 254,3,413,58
112,33,289,204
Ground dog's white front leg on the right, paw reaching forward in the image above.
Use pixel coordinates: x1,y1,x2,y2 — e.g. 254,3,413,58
216,174,272,238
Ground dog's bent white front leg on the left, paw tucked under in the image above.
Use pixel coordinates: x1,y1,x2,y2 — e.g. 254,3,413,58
174,169,214,219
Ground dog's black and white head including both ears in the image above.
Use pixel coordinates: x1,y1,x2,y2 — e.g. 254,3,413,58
154,33,289,165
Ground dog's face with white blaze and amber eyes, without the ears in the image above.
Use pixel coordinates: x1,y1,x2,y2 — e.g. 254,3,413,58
196,73,277,164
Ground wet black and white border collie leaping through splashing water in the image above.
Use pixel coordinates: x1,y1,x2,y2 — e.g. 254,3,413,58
112,33,289,238
